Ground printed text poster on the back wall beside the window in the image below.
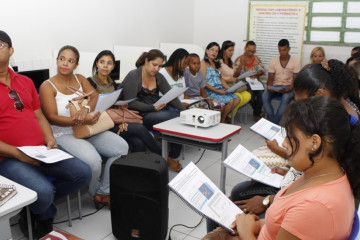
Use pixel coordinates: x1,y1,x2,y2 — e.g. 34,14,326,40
249,2,307,79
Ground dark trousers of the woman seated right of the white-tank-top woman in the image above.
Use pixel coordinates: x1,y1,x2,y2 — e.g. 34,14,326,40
116,123,161,155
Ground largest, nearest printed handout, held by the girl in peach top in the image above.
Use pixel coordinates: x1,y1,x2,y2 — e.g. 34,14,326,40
169,162,242,232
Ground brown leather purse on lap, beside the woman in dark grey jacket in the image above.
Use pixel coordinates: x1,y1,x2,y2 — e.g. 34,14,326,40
106,107,143,124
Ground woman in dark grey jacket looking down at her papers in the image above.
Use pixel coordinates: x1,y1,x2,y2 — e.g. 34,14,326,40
120,49,185,172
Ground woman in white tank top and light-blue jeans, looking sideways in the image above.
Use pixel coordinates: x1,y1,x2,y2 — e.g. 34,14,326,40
40,46,128,207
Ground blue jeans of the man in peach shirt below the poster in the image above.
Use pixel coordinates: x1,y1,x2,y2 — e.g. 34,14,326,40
262,88,294,124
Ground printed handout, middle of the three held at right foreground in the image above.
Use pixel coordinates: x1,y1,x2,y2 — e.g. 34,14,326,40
224,144,284,188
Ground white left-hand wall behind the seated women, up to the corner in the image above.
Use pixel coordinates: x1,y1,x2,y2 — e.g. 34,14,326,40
0,0,193,70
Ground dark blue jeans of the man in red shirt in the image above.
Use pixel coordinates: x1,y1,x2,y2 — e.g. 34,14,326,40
0,153,91,221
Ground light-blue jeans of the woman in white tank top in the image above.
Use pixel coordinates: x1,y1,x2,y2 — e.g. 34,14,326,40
56,131,129,196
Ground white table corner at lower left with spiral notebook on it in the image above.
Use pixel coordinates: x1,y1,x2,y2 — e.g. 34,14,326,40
0,175,37,240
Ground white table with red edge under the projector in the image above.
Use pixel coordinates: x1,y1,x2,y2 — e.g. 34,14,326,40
153,117,241,193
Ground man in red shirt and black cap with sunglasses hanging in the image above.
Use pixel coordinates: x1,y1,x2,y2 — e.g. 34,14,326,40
0,30,91,238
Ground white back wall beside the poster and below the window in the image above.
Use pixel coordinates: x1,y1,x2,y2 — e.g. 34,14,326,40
194,0,352,65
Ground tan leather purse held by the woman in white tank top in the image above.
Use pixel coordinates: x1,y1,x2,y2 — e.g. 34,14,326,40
68,88,114,138
